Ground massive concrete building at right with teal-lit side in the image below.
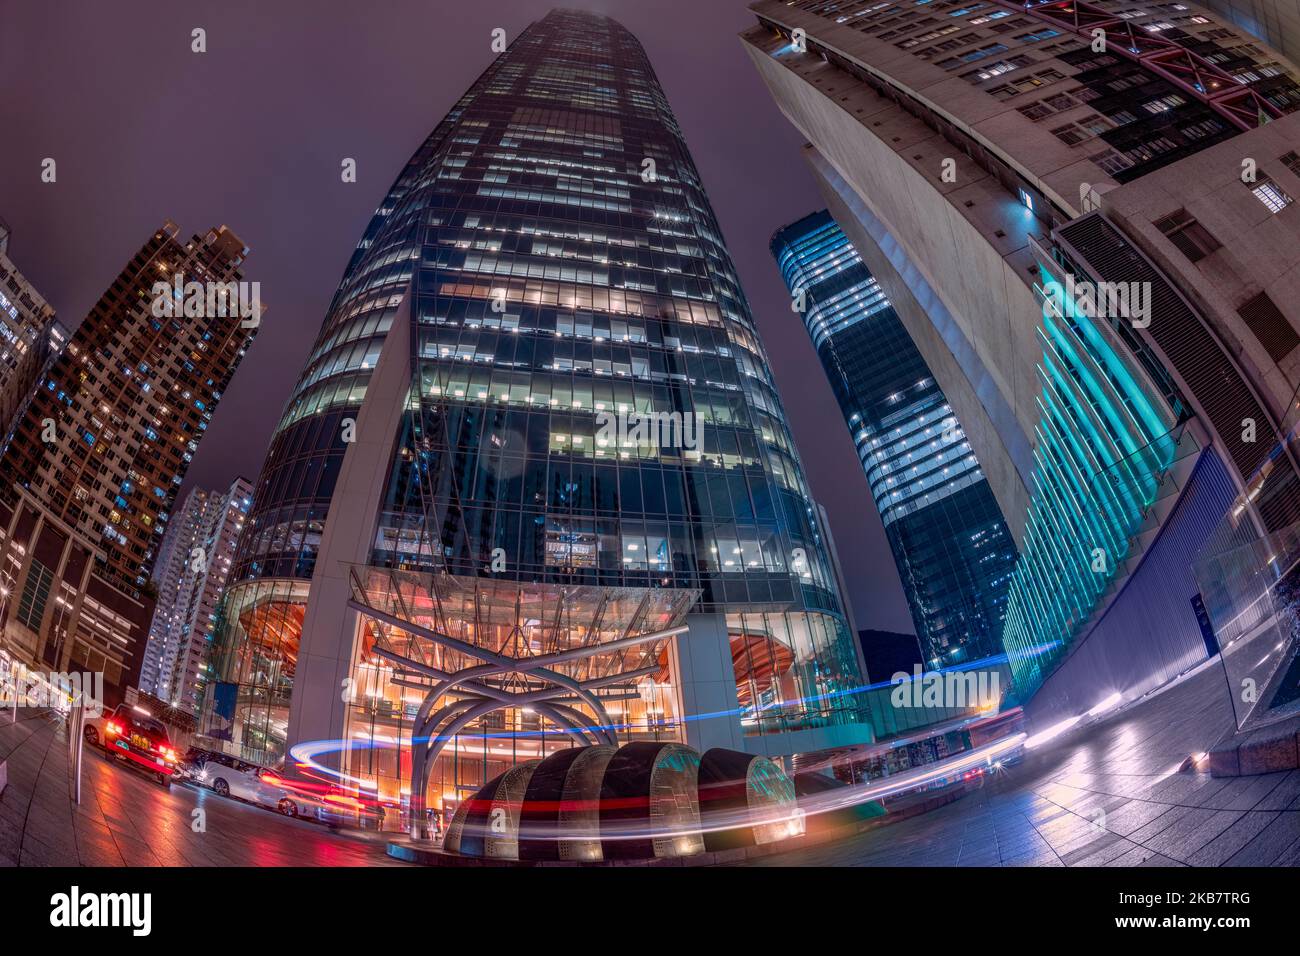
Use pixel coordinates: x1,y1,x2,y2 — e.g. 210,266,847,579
741,0,1300,721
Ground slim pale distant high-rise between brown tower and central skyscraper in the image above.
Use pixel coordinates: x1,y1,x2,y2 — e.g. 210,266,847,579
140,477,252,713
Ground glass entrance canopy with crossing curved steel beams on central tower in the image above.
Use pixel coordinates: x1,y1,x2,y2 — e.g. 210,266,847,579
348,566,699,819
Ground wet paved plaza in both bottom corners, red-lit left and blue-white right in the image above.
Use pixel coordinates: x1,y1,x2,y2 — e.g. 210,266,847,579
0,665,1300,866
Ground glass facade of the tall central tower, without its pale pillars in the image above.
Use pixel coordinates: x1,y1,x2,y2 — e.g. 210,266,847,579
208,12,859,799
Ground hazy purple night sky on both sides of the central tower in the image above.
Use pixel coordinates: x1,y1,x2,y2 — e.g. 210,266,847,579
0,0,914,632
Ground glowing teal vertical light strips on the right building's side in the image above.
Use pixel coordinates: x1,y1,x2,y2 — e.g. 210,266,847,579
1002,267,1178,700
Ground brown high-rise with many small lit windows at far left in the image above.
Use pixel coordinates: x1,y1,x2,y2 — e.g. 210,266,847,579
0,222,256,702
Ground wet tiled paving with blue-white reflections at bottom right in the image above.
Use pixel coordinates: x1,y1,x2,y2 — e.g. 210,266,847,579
759,666,1300,866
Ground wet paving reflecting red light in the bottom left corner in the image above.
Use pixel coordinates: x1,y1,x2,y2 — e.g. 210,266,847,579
0,710,402,866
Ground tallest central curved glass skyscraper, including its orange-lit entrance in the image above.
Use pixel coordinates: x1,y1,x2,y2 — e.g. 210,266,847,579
203,12,870,805
